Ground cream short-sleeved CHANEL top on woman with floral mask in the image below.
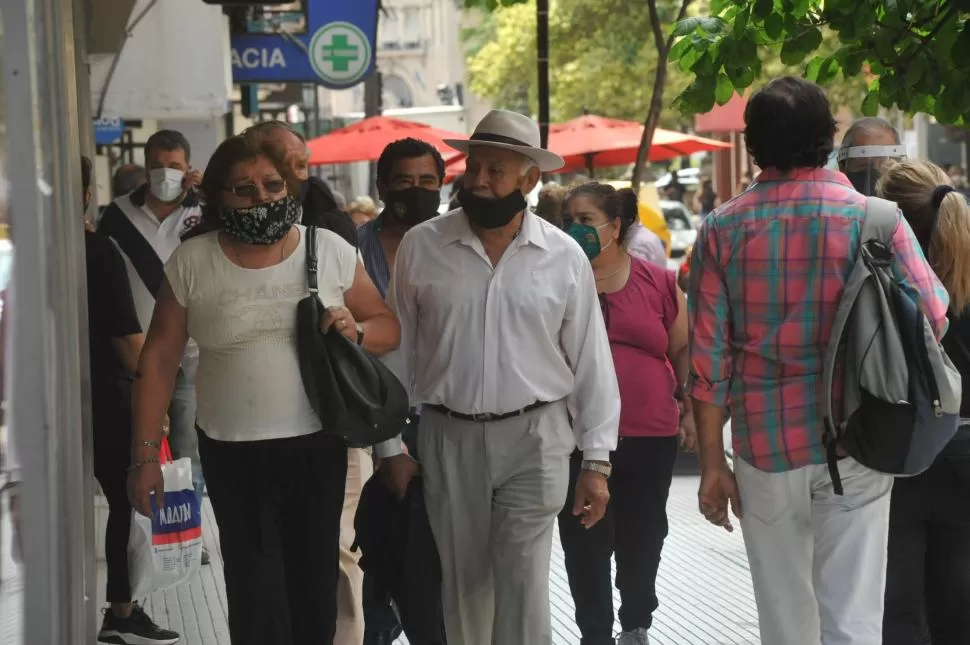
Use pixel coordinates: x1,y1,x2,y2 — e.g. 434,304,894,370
165,226,357,441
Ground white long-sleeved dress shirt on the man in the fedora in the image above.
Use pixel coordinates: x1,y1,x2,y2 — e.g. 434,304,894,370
377,209,620,461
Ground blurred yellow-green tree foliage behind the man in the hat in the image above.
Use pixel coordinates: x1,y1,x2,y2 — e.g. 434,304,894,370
464,0,690,127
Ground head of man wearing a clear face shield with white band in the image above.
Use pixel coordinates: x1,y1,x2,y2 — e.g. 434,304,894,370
838,117,906,196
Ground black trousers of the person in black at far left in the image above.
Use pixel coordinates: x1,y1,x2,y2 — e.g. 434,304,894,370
92,388,131,603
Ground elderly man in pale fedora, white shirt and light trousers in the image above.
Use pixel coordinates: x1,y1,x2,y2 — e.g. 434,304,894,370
377,110,620,645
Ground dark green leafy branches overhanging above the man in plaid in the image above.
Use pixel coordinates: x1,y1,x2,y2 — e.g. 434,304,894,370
671,0,970,124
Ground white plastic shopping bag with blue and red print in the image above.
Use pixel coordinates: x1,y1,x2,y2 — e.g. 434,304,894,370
128,459,202,598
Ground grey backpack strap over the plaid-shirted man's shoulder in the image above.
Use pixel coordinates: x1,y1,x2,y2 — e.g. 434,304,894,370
822,197,899,495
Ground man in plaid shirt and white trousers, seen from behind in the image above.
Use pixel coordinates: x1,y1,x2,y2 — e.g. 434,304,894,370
688,77,948,645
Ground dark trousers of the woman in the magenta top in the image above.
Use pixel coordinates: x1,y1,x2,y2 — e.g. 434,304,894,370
559,437,677,645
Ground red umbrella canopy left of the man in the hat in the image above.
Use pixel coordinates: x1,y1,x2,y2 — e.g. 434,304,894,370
307,116,468,166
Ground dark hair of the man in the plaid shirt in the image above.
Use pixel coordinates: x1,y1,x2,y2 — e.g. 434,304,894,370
744,76,836,172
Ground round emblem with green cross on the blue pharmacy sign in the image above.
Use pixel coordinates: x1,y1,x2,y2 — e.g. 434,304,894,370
308,22,373,87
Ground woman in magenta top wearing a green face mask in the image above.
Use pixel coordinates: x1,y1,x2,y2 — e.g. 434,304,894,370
559,182,696,645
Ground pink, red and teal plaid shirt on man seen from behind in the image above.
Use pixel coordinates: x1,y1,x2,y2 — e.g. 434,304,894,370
688,169,949,472
